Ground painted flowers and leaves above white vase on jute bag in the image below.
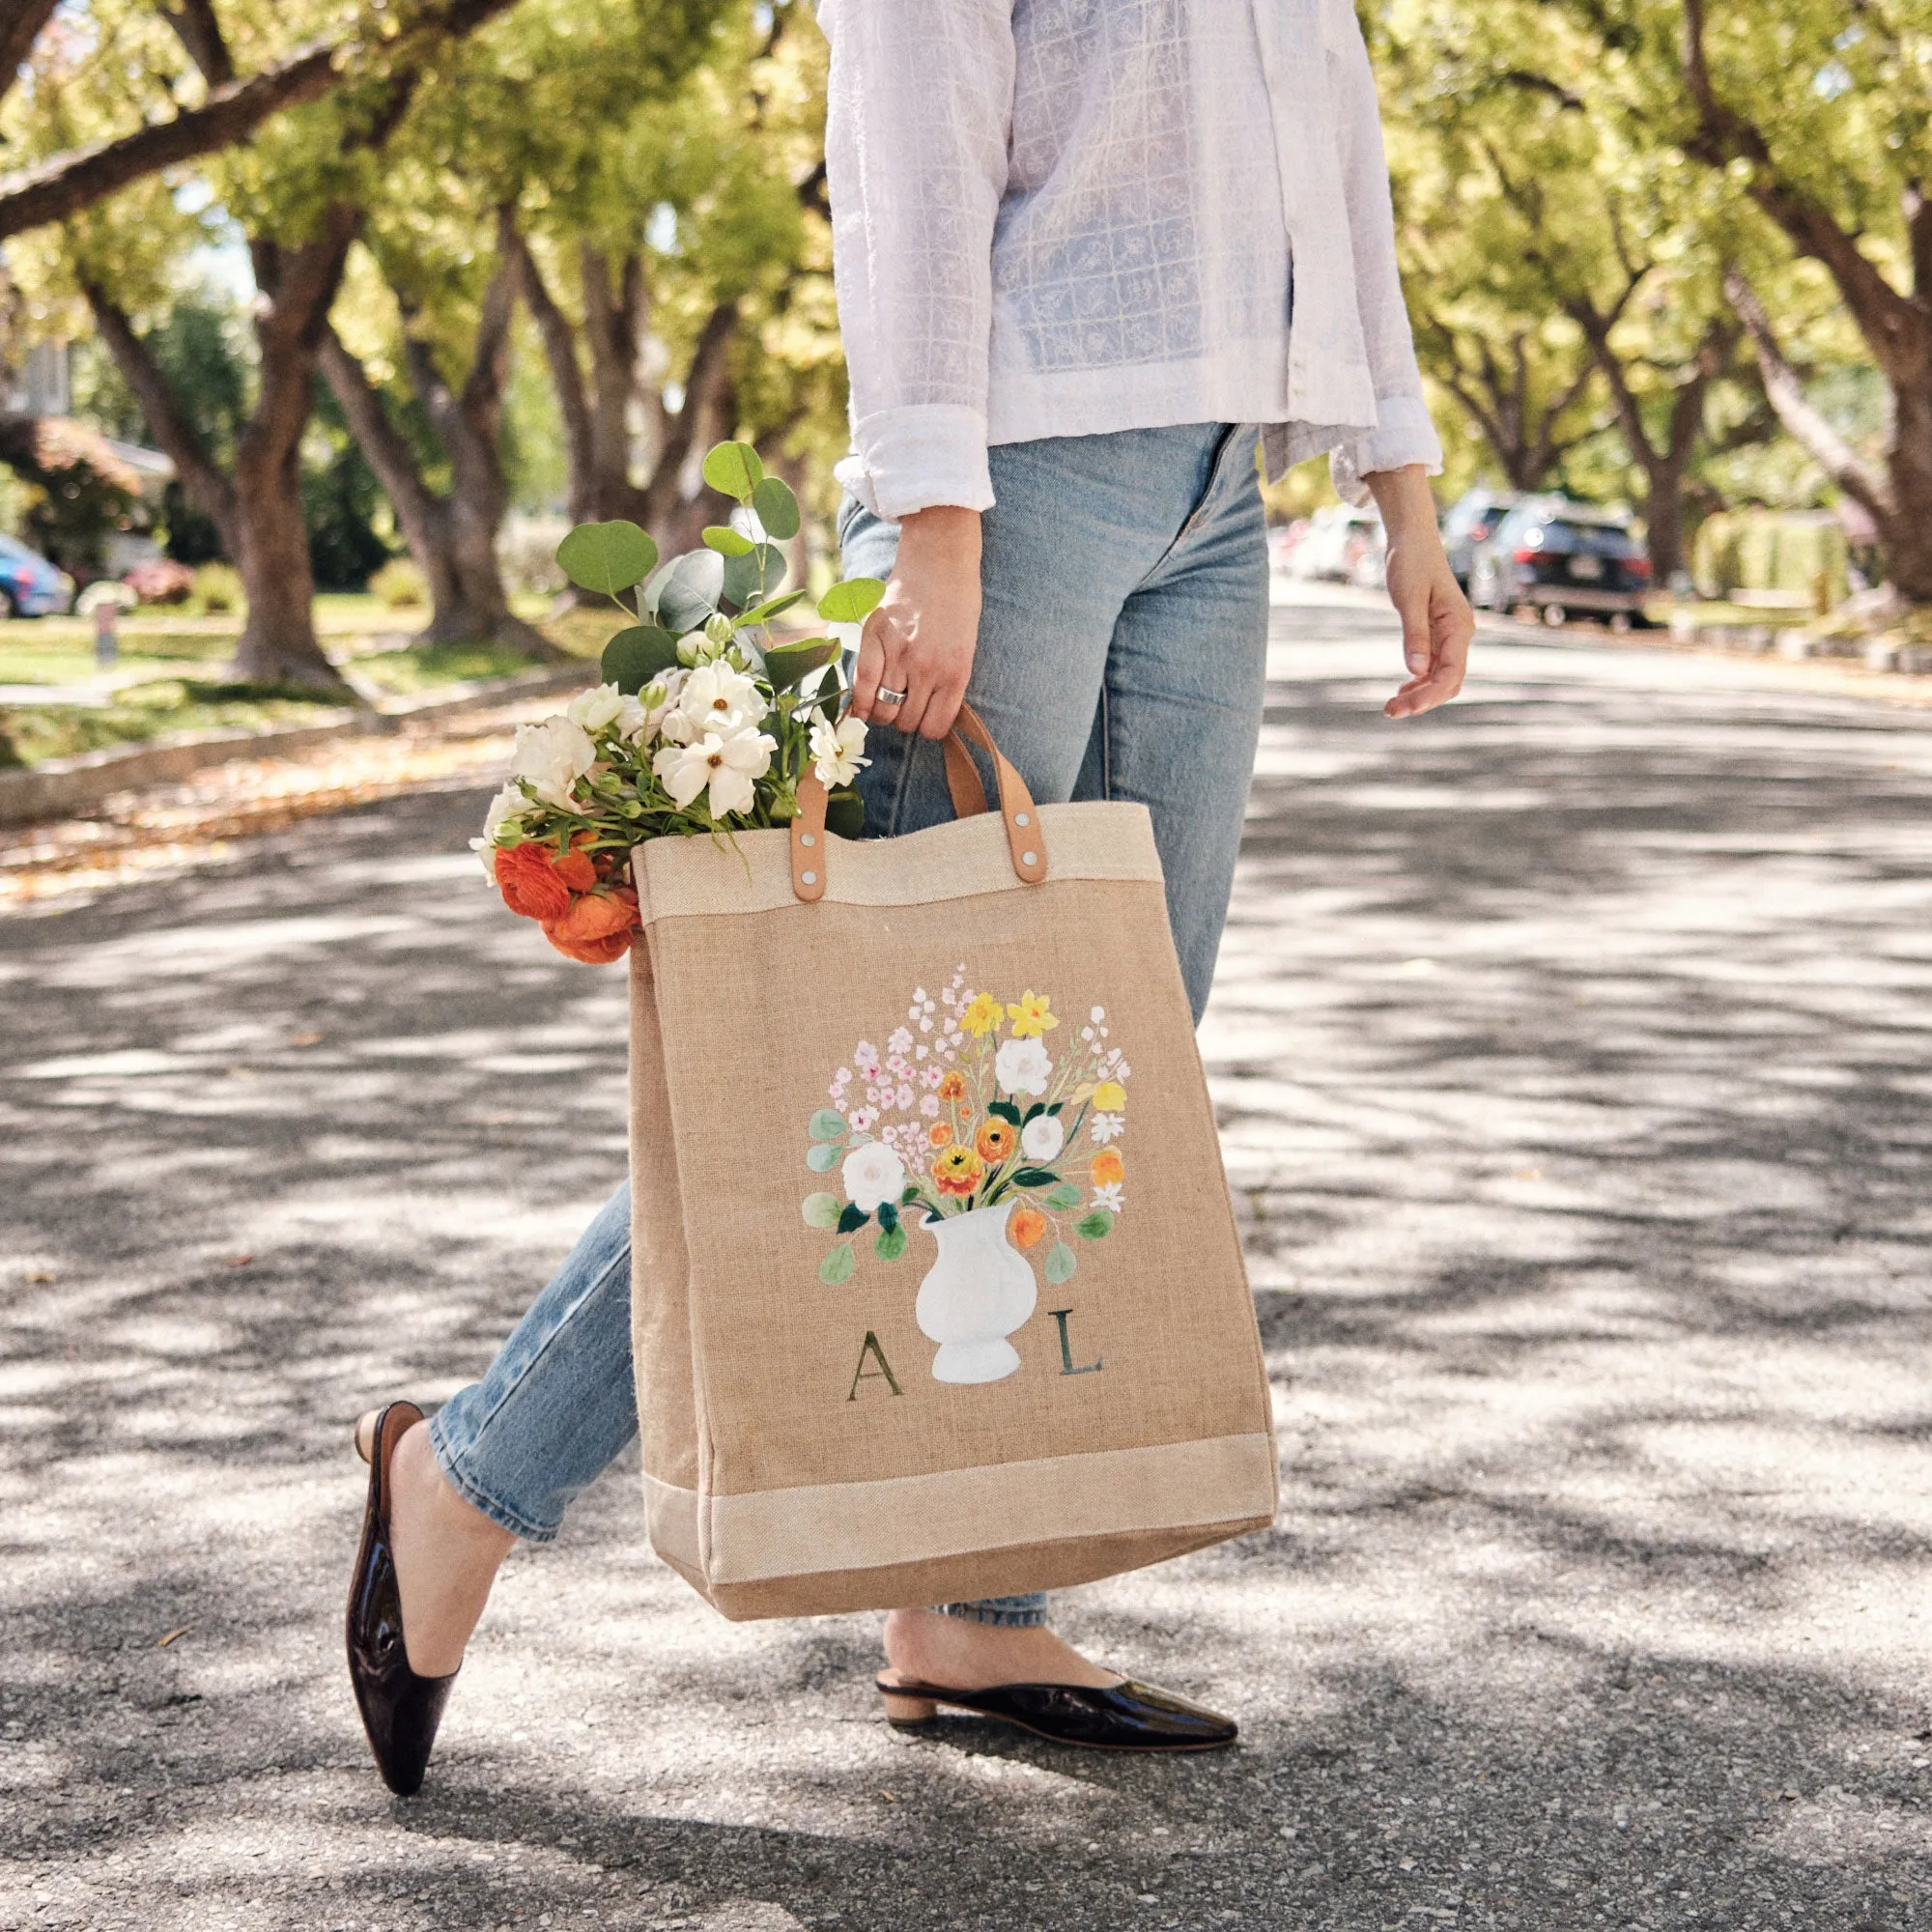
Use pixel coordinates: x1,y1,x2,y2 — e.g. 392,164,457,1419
802,966,1130,1287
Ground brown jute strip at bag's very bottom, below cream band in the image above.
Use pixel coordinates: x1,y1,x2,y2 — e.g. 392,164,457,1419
659,1517,1273,1623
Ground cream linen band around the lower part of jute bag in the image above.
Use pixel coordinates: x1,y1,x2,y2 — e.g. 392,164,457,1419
643,1435,1275,1584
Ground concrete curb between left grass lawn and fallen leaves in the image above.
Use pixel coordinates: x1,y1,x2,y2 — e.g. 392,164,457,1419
0,659,597,825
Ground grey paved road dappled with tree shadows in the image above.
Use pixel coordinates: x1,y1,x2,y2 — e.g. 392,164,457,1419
0,595,1932,1932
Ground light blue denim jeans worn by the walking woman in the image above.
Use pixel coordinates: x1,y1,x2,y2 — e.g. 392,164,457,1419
429,423,1267,1625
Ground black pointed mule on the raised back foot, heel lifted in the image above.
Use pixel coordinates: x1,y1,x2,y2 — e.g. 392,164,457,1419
348,1403,456,1797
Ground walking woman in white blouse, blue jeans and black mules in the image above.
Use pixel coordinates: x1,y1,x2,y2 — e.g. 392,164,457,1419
350,0,1472,1791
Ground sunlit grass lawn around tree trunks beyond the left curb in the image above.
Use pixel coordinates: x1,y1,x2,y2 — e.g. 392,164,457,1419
0,595,622,765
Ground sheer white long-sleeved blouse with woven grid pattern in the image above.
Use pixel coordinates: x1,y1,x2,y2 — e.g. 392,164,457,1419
819,0,1441,516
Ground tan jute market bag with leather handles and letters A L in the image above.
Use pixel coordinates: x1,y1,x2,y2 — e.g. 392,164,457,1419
630,713,1275,1617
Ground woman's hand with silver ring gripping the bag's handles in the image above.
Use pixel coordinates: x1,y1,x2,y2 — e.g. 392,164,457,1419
852,504,980,738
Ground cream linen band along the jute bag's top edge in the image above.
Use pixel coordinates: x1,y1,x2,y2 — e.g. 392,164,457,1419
632,800,1161,925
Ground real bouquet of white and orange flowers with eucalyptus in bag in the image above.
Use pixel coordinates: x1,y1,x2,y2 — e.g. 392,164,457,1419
471,442,885,964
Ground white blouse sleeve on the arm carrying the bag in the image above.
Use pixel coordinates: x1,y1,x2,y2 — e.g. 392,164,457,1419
819,0,1014,516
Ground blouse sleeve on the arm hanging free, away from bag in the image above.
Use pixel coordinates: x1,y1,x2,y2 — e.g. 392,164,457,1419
1329,0,1443,502
